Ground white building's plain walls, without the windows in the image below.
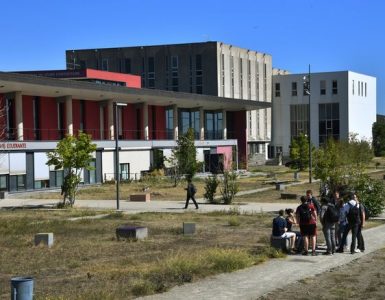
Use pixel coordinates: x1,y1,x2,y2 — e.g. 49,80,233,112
271,71,376,155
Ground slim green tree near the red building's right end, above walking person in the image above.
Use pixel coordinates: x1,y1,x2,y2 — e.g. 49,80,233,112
173,128,197,178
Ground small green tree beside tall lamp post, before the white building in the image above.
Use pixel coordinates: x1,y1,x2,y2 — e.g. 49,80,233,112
290,133,309,171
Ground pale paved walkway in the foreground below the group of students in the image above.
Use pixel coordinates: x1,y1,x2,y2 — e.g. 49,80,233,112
142,225,385,300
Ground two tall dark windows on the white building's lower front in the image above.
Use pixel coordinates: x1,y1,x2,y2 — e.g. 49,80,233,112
290,103,340,145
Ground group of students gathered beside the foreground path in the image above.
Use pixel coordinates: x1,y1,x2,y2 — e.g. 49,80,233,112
272,190,367,256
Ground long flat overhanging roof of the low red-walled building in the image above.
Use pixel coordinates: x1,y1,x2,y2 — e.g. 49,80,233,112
0,72,271,111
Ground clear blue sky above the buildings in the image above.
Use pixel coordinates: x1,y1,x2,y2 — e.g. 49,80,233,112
0,0,385,114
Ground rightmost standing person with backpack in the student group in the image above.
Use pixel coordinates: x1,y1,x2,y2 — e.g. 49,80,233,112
336,193,361,254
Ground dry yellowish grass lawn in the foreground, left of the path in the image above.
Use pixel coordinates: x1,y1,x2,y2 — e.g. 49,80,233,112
0,210,282,299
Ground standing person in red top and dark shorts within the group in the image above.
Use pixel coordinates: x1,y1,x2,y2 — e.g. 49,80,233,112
296,196,317,256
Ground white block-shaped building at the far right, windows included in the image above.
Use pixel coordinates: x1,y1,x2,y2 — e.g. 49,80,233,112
270,71,377,157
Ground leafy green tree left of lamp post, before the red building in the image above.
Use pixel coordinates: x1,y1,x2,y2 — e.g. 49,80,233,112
47,132,96,206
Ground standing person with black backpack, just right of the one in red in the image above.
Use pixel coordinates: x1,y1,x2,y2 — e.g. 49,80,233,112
320,198,340,255
